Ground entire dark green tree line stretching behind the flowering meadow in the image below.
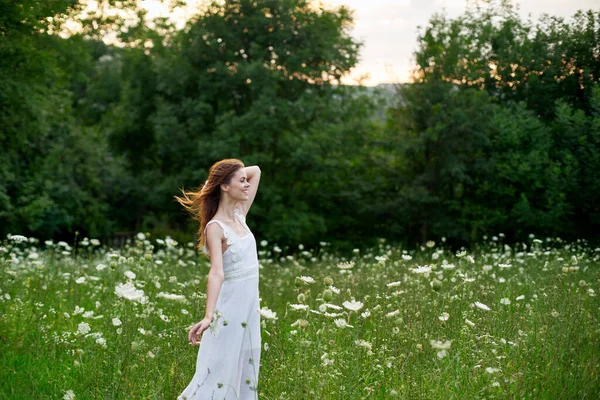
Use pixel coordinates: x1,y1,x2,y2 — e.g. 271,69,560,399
0,0,600,247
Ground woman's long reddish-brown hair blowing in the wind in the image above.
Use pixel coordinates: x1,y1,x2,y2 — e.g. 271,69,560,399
175,158,244,251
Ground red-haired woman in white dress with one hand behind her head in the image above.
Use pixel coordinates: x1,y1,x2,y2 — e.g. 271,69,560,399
175,159,261,400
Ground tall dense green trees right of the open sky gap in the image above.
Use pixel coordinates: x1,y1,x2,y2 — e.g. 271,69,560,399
387,2,600,243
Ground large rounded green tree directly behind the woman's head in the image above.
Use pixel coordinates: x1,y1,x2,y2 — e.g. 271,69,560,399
105,0,374,244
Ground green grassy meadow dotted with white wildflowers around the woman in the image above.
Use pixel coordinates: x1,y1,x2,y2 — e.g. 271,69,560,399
0,233,600,400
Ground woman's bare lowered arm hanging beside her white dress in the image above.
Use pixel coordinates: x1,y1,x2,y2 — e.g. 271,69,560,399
188,224,224,345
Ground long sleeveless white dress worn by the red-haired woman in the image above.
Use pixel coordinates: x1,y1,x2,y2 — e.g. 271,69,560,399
177,208,261,400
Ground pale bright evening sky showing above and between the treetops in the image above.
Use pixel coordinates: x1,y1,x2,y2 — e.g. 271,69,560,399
141,0,600,86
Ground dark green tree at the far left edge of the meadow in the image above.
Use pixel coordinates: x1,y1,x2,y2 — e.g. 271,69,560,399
0,0,122,237
